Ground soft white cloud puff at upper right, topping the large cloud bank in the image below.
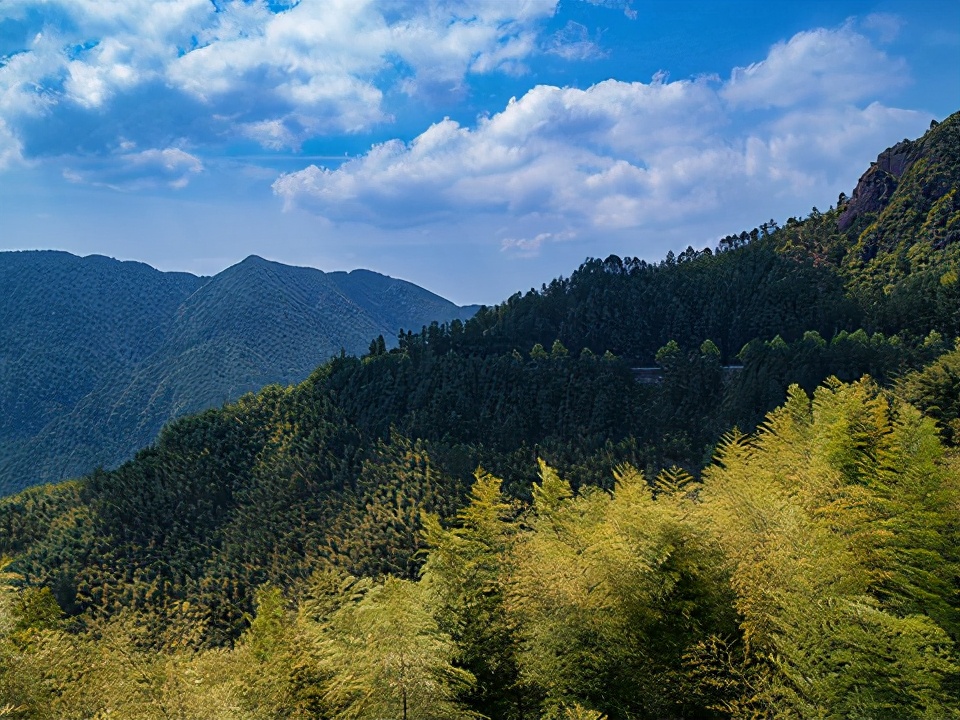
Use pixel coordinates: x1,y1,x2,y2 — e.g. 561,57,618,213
723,23,908,109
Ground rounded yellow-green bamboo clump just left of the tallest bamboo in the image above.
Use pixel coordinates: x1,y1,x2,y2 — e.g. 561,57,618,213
513,468,736,718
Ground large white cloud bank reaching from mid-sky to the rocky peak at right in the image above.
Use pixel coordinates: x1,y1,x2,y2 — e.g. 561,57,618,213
273,21,929,255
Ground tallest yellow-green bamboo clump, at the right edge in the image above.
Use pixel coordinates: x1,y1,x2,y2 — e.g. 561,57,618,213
702,382,960,718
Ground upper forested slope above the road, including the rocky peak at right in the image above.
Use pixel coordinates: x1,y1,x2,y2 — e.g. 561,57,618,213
452,113,960,365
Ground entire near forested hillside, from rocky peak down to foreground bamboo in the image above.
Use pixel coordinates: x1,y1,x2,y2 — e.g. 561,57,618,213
0,115,960,720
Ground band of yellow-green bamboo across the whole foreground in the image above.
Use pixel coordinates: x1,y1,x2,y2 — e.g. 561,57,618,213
0,380,960,720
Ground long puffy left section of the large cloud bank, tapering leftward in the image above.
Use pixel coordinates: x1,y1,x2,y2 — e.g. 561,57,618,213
274,80,718,227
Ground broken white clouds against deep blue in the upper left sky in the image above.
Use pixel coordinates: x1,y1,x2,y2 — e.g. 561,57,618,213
0,0,557,167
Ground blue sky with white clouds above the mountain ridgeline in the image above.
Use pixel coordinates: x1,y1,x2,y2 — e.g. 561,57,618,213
0,0,960,304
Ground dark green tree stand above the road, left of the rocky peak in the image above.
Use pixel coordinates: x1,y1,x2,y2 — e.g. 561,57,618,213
462,242,861,365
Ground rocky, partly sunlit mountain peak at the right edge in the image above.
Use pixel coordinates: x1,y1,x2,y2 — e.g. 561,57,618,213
776,113,960,337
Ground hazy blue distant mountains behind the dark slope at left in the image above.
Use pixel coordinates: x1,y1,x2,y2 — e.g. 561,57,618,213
0,251,477,494
